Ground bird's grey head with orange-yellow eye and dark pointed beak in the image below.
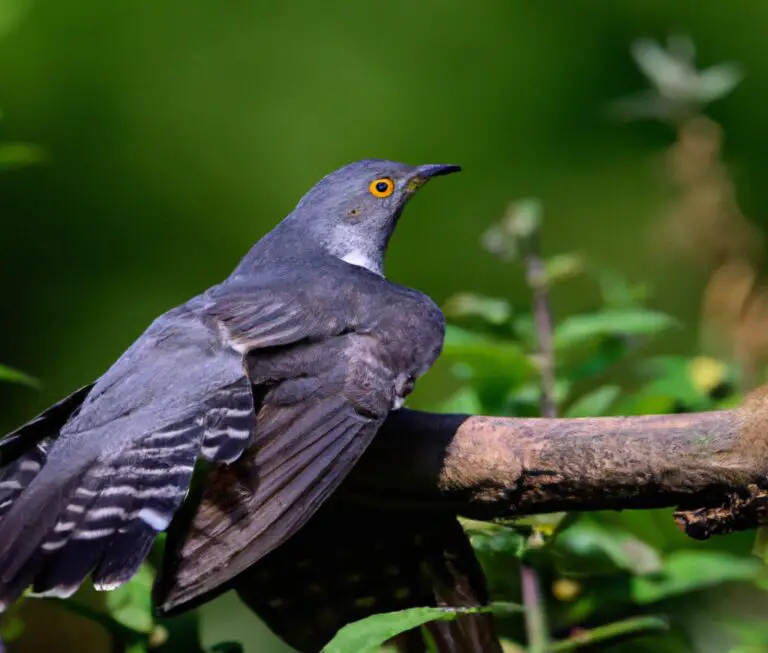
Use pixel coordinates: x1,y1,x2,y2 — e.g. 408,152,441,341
286,159,461,274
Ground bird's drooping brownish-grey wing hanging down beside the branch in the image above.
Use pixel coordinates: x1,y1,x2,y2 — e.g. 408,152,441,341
155,333,395,614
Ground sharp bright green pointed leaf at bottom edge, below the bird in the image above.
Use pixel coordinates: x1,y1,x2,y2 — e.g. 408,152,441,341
322,608,490,653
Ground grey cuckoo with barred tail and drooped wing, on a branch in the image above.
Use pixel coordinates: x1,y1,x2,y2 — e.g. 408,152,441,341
0,159,504,652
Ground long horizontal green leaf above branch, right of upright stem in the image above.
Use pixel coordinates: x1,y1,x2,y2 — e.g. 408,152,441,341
554,309,678,349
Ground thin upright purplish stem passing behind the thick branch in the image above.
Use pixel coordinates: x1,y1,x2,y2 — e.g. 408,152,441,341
519,205,557,653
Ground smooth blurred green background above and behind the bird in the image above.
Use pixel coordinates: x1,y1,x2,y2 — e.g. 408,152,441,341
0,0,768,651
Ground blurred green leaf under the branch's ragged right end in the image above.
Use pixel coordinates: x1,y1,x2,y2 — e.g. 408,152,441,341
631,551,765,604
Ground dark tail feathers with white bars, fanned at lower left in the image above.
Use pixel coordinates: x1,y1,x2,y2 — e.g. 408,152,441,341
0,378,255,611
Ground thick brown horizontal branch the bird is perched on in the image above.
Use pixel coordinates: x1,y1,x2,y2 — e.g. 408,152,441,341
344,389,768,537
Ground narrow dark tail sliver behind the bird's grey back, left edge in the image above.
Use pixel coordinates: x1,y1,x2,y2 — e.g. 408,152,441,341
0,385,93,520
